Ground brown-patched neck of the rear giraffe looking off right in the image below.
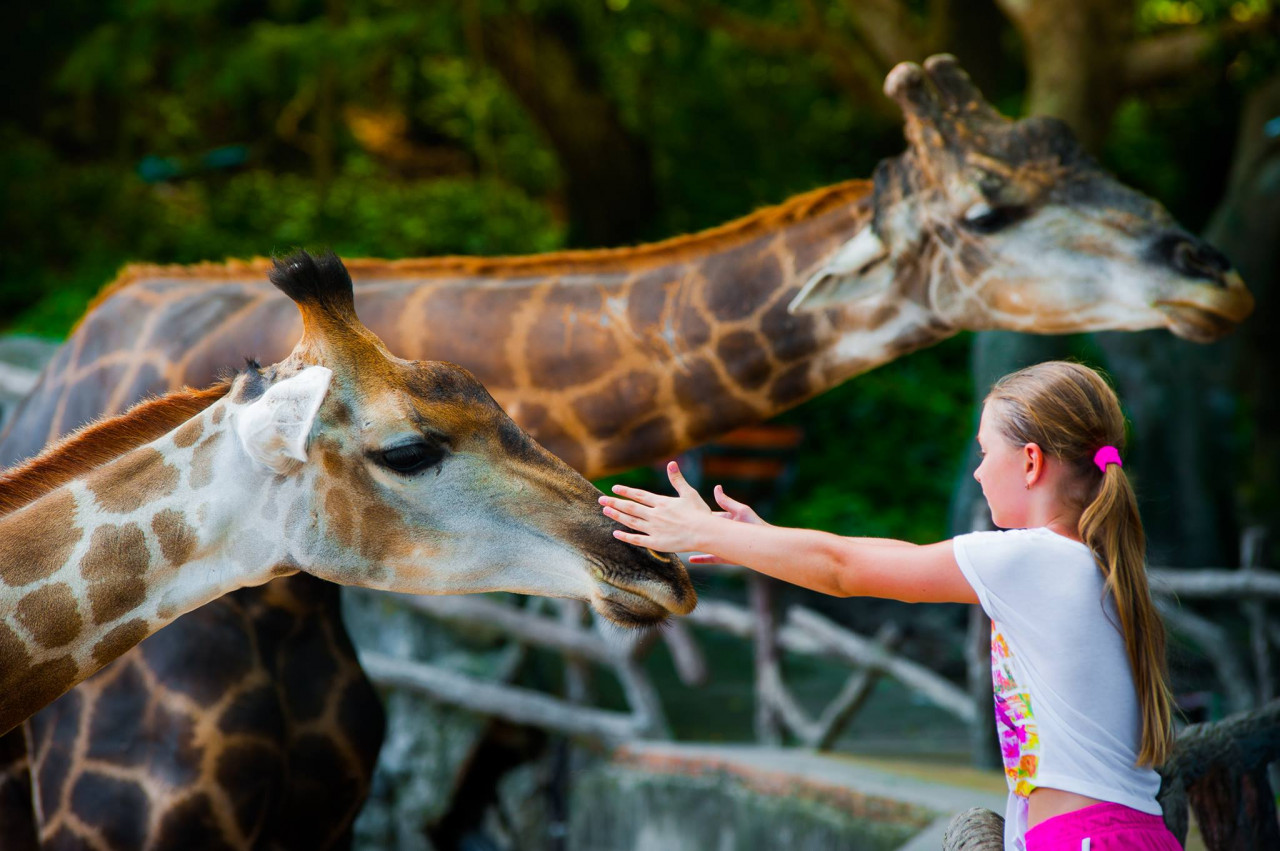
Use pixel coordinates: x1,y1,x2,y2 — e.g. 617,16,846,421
371,184,952,476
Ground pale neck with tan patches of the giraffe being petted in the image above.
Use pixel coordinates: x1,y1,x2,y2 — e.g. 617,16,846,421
0,399,297,732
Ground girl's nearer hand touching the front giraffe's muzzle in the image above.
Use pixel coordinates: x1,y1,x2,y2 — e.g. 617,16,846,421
599,461,721,553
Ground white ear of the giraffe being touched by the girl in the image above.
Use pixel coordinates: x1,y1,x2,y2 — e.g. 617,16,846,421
232,366,333,473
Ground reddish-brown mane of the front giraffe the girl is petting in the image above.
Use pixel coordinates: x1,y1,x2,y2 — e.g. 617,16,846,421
0,378,232,517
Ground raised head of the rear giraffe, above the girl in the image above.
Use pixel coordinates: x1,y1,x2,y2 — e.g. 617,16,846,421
792,55,1253,342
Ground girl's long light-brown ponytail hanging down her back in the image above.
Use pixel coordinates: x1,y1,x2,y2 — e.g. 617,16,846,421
1079,463,1174,765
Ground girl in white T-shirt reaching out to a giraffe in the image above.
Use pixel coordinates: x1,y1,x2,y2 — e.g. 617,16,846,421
600,362,1179,851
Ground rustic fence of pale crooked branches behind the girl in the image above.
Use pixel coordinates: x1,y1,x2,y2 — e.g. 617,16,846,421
361,531,1280,756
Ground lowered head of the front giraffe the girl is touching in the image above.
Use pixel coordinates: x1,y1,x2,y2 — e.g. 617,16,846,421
230,252,696,624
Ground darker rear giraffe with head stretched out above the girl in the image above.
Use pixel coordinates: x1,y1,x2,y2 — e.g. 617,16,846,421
0,56,1252,844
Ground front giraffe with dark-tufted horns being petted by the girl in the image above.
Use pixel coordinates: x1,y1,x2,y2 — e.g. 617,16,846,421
0,252,696,848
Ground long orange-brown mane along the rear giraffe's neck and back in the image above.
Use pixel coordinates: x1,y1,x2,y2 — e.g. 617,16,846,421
80,179,872,326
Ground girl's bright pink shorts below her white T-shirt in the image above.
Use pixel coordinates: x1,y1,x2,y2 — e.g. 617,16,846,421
1027,804,1183,851
